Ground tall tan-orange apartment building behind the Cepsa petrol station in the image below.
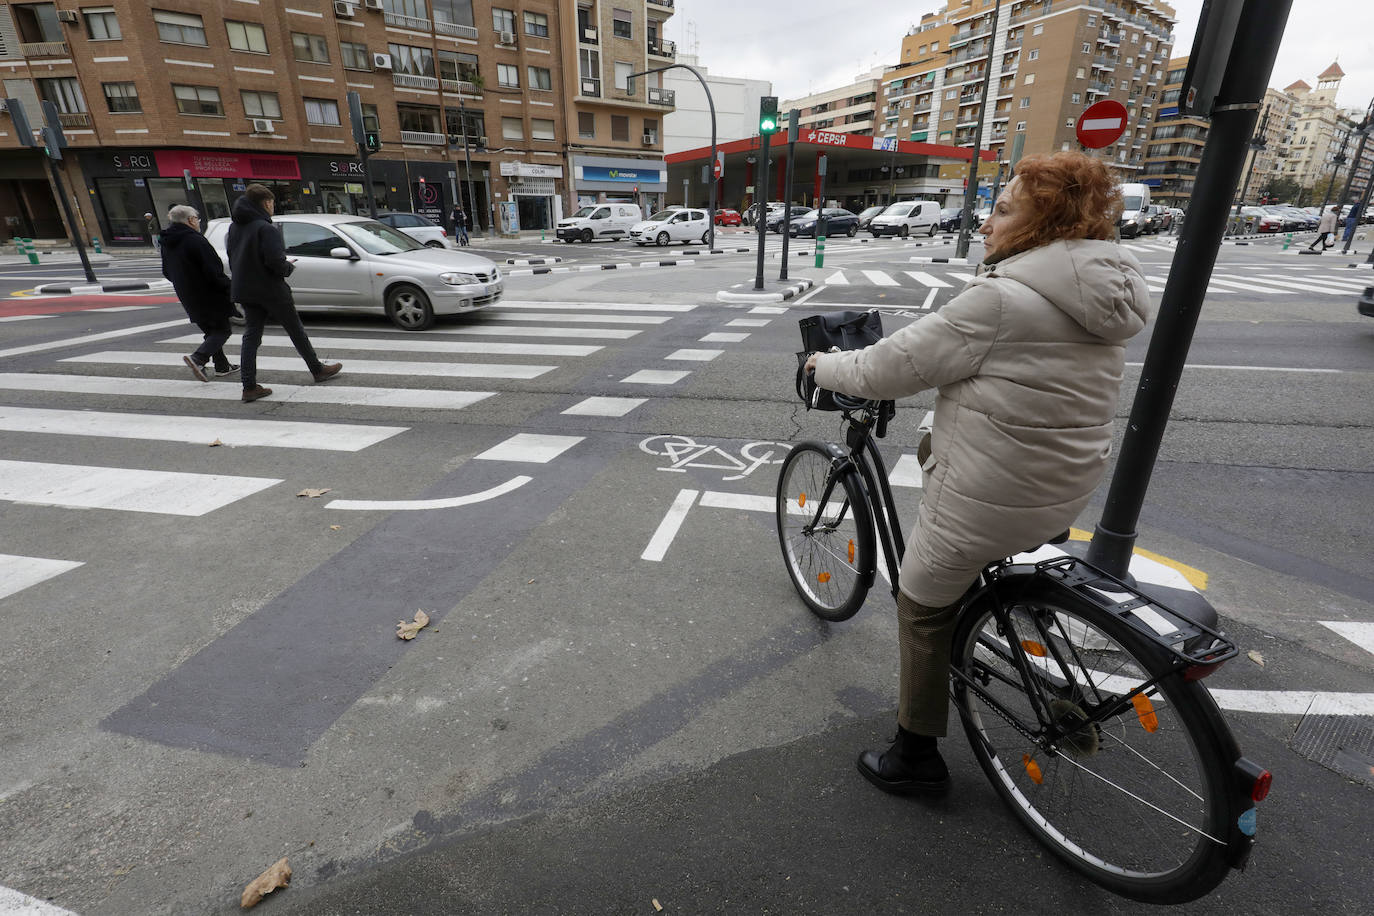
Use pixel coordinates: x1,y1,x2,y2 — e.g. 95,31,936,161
877,0,1173,180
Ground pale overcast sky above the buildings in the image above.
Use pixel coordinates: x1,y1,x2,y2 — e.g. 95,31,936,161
665,0,1374,118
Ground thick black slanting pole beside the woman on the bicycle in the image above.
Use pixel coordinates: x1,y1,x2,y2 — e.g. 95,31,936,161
1088,0,1293,578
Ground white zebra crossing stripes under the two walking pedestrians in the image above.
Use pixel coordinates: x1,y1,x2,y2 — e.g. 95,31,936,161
0,301,736,600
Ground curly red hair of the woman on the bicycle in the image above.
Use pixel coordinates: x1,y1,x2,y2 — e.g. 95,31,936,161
998,151,1121,257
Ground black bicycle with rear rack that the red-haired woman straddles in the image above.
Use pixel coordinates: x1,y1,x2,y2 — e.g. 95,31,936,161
776,396,1270,904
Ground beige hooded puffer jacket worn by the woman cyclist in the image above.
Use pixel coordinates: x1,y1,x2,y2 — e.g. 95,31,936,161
816,239,1150,607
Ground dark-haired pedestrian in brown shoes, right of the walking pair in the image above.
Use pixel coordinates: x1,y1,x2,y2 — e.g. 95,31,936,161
227,183,344,401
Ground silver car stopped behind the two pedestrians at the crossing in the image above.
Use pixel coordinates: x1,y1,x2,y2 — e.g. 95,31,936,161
205,213,506,331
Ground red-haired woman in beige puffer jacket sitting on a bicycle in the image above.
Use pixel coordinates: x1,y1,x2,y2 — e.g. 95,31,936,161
807,152,1150,794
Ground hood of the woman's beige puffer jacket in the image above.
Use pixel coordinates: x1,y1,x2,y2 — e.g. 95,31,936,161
992,239,1150,341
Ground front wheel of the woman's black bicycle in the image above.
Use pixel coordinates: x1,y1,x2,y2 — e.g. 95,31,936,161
775,442,875,621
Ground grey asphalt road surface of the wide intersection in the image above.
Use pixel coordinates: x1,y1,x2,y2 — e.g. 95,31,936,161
0,236,1374,916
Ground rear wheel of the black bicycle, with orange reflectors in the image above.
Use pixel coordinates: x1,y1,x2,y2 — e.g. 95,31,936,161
951,575,1238,904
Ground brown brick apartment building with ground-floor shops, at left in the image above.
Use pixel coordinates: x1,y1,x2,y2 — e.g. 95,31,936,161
0,0,672,244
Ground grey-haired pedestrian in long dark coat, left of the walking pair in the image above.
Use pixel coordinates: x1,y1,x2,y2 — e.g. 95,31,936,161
159,203,239,382
